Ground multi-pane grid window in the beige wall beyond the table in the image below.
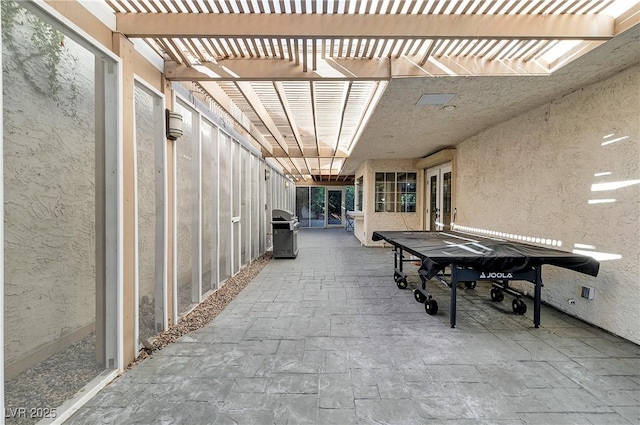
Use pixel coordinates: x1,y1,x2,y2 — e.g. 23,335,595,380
375,173,416,212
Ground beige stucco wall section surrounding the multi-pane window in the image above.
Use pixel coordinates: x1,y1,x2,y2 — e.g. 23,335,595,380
354,159,424,246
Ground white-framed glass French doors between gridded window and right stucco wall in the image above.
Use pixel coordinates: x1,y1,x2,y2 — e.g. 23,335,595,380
424,162,452,231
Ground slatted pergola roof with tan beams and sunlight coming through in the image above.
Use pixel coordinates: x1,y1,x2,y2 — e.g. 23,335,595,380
104,0,640,180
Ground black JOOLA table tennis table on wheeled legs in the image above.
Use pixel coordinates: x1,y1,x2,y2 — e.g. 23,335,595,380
372,231,600,328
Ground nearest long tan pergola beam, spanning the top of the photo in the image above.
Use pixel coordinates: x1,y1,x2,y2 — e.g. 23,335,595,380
116,13,615,40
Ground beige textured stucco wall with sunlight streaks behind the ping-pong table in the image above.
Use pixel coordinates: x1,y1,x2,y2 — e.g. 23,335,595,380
455,66,640,343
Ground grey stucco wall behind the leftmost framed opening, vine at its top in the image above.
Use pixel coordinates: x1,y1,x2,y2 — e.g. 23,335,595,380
3,14,96,365
